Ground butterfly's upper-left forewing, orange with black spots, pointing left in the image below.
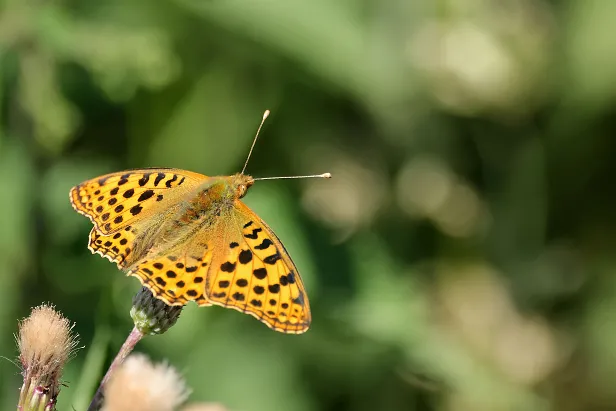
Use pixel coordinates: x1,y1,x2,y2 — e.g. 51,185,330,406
70,168,208,237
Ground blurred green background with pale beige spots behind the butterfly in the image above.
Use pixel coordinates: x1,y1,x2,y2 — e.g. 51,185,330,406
0,0,616,411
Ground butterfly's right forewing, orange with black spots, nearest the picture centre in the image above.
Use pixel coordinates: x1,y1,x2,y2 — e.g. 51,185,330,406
205,200,311,334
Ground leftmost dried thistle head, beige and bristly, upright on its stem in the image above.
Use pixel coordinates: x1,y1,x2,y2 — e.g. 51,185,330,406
16,304,78,410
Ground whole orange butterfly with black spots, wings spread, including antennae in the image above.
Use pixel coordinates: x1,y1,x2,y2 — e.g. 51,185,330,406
70,111,331,334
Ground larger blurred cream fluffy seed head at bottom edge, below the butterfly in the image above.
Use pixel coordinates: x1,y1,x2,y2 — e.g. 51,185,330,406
103,354,189,411
